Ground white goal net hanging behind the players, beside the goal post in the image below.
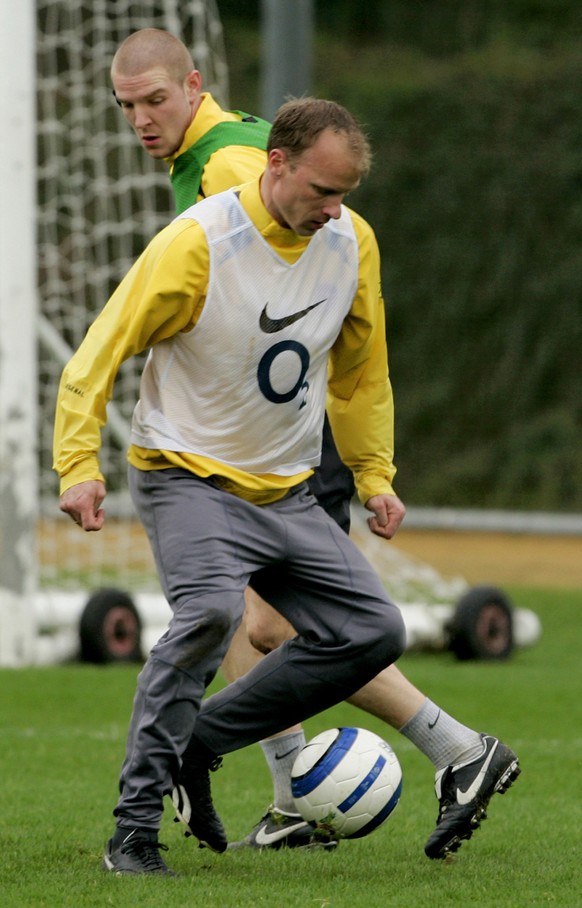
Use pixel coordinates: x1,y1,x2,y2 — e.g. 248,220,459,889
36,0,228,590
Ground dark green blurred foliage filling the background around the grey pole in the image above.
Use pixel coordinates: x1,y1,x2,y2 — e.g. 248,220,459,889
218,0,582,511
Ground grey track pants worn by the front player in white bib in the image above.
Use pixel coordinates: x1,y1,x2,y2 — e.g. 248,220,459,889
114,467,405,829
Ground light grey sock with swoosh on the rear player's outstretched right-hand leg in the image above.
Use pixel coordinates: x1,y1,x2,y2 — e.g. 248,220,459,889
399,698,483,770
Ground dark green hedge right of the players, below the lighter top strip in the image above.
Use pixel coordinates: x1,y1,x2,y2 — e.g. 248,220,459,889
336,49,582,509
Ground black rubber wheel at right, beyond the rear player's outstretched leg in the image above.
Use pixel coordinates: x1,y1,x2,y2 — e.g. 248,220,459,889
449,586,513,659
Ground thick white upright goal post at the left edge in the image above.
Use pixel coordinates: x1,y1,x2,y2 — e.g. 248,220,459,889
0,3,38,666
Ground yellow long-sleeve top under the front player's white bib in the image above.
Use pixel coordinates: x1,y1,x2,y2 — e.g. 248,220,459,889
54,179,396,504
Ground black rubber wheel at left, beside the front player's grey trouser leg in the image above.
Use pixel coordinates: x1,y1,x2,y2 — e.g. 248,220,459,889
79,589,143,665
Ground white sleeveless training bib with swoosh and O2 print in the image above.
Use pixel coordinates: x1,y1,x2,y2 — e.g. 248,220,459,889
132,191,358,476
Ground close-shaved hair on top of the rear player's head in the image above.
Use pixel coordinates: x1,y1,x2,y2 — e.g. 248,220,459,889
111,28,195,83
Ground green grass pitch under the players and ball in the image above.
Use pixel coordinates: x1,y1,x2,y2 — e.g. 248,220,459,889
0,589,582,908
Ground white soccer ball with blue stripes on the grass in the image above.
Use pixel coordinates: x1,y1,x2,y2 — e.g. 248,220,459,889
291,728,402,839
